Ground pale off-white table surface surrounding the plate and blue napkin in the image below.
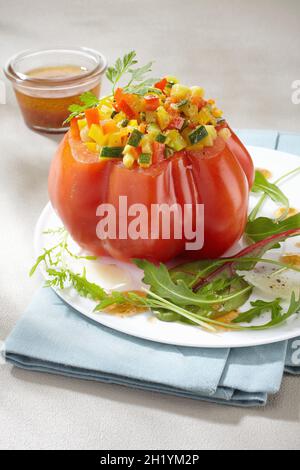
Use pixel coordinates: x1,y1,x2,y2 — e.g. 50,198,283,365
0,0,300,449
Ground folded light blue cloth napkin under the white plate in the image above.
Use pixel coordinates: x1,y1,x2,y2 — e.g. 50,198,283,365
5,131,300,407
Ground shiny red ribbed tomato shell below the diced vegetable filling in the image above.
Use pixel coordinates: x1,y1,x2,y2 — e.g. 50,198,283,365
49,133,249,262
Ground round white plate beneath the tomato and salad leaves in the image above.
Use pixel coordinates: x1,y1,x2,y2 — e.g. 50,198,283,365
34,147,300,348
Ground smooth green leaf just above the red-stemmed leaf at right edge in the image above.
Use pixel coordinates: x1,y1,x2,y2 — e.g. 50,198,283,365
245,213,300,242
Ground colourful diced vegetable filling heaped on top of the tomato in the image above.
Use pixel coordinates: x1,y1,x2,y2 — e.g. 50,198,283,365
71,77,230,169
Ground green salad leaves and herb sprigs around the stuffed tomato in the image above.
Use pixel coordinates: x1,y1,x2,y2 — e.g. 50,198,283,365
30,156,300,331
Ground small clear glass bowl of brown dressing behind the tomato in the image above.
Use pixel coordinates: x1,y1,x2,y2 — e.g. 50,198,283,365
4,47,107,133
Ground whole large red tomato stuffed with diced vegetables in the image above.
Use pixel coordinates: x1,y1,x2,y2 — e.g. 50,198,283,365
49,77,254,262
